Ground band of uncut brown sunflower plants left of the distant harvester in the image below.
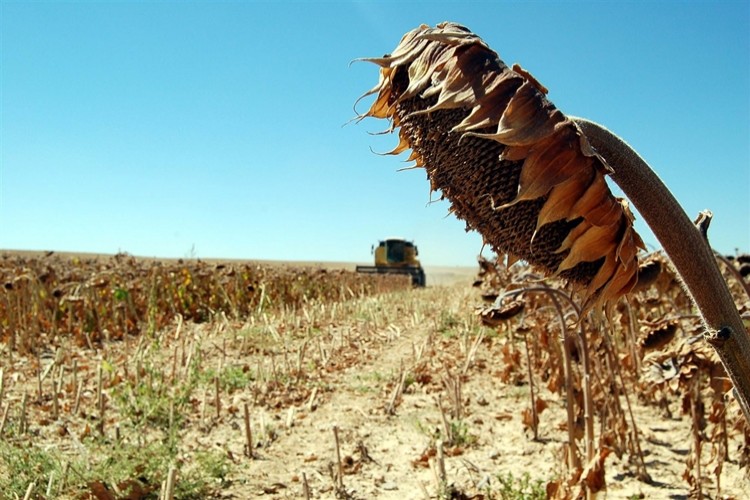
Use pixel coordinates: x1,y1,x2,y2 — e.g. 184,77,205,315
0,254,410,354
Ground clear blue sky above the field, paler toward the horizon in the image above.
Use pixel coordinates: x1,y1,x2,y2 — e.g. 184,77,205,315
0,0,750,266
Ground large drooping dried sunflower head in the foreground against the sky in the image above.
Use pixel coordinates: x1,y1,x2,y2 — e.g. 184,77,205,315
361,23,643,307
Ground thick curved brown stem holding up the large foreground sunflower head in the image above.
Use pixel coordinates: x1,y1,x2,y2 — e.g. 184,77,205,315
571,117,750,422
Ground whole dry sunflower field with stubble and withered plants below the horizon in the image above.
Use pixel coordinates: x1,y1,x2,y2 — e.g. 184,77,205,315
0,254,750,499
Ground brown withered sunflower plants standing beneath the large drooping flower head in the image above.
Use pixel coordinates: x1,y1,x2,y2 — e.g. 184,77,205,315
475,253,750,498
